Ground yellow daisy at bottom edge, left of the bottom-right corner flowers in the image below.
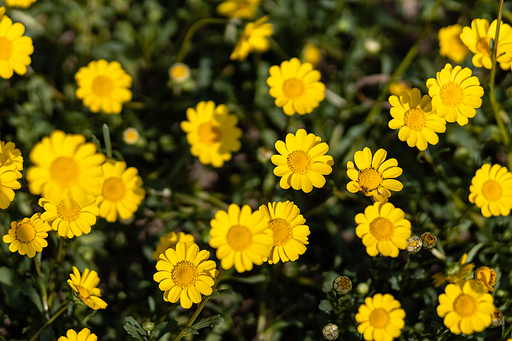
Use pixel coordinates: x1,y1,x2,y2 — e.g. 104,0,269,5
356,294,405,341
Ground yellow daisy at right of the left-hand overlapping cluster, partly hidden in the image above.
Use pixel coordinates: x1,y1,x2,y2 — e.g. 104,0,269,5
96,161,146,223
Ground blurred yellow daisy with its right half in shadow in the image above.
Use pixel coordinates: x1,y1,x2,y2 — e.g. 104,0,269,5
181,101,242,167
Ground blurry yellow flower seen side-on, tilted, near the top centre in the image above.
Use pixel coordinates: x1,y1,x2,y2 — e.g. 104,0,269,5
229,15,274,62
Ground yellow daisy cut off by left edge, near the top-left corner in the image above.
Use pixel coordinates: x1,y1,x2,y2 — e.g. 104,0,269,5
0,17,34,79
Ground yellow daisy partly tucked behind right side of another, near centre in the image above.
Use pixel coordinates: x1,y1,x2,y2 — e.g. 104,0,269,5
259,201,309,264
